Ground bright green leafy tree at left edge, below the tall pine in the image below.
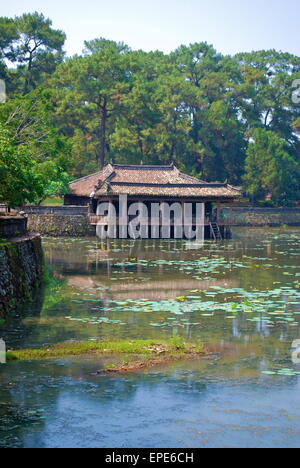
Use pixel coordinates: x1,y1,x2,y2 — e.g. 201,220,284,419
0,88,72,206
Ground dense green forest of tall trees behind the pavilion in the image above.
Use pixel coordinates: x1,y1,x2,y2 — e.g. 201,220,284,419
0,13,300,205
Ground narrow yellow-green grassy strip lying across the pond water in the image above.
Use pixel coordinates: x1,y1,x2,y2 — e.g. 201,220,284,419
7,336,205,361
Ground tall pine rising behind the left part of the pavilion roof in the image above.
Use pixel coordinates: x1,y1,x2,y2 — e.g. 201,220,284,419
53,39,130,168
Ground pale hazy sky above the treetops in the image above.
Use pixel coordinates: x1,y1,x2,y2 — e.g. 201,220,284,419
0,0,300,55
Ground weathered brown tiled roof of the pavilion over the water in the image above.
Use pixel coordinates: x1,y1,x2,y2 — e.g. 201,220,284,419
70,164,240,199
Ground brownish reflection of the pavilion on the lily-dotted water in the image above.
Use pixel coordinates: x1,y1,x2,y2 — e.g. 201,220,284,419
47,241,238,300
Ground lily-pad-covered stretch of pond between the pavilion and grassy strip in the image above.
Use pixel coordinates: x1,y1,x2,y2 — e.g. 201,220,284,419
5,230,300,362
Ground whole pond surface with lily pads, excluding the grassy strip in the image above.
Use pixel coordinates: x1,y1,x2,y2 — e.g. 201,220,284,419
0,229,300,448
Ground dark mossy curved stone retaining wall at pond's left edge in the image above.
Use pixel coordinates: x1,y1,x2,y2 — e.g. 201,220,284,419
0,235,44,318
